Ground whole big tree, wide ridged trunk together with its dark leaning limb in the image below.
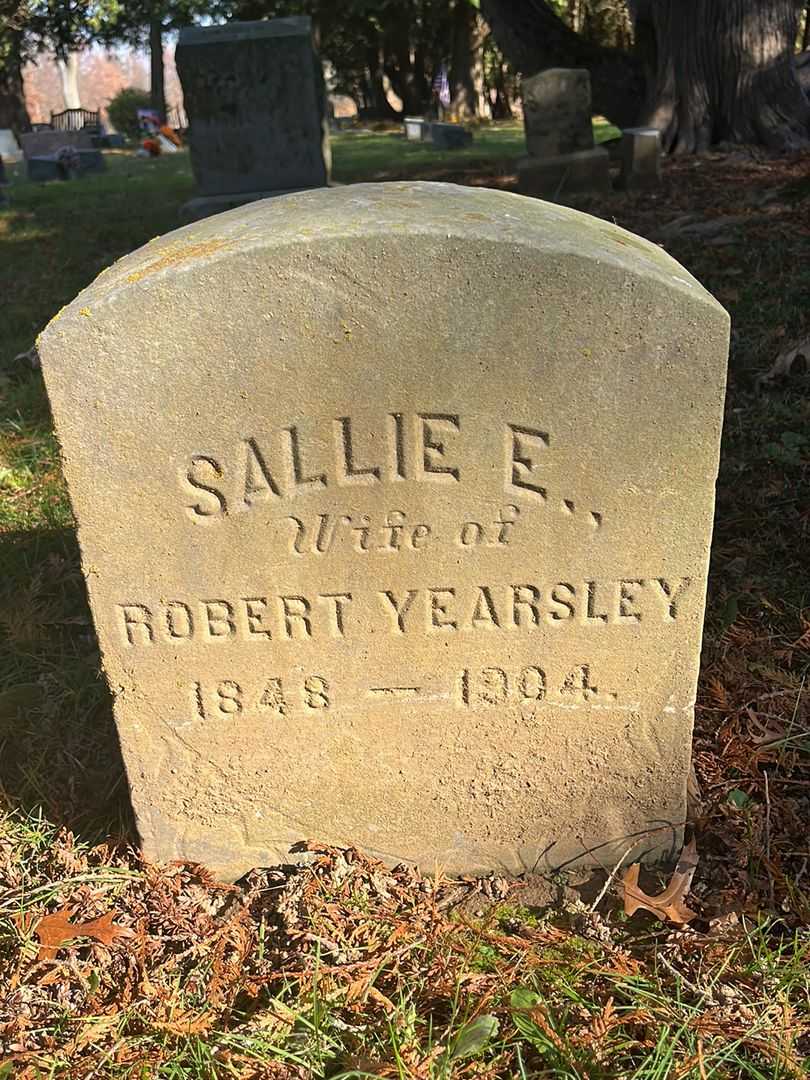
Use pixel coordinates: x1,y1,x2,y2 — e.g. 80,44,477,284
481,0,810,153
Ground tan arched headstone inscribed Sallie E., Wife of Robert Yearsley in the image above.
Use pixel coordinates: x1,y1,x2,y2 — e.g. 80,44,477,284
39,183,728,878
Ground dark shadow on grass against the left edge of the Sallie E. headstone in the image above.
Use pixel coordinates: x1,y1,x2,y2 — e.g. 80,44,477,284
0,528,135,840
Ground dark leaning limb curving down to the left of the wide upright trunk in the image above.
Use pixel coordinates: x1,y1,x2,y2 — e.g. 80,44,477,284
481,0,648,127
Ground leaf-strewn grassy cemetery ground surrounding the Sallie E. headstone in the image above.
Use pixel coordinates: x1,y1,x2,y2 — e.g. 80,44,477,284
0,139,810,1080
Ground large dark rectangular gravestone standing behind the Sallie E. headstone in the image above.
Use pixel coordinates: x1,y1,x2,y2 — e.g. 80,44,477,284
176,16,332,220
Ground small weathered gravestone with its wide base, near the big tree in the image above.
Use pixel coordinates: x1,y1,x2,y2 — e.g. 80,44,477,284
517,68,610,198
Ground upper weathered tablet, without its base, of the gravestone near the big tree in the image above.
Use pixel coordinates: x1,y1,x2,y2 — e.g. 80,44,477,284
522,68,593,158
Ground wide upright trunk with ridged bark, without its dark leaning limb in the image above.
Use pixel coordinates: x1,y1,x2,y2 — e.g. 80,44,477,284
645,0,810,153
